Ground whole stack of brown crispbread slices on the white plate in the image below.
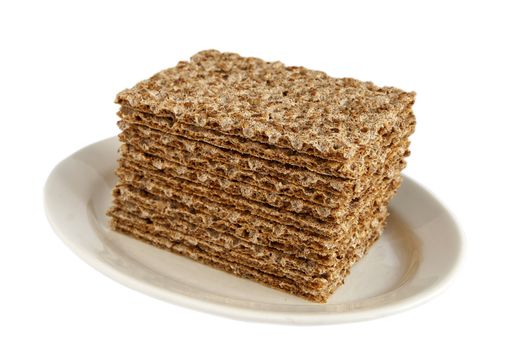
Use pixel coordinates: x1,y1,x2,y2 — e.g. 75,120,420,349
109,50,415,302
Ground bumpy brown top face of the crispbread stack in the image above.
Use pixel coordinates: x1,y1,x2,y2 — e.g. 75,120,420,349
116,50,414,161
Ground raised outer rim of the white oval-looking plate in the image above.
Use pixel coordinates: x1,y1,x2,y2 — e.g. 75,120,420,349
43,136,466,325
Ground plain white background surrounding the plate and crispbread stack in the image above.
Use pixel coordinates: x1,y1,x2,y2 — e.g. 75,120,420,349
0,0,523,349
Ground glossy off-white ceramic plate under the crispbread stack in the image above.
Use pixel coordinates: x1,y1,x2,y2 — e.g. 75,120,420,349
44,137,462,324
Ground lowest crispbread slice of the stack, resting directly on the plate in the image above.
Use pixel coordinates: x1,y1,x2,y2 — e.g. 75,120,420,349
111,212,383,303
